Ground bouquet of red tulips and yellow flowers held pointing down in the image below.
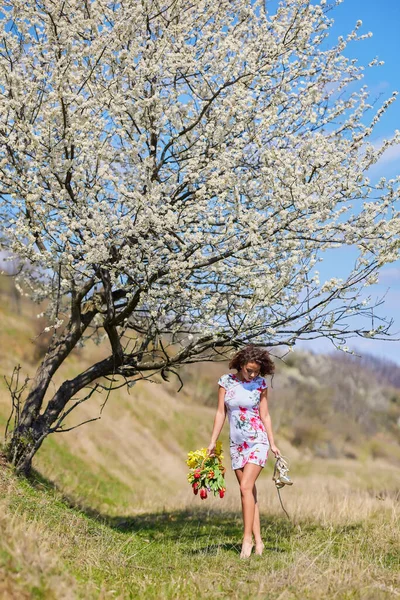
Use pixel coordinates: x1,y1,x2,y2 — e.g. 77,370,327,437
186,442,226,500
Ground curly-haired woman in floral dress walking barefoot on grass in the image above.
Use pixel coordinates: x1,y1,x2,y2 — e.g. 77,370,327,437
208,346,280,558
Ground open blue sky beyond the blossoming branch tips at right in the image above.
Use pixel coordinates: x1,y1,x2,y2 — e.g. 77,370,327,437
302,0,400,364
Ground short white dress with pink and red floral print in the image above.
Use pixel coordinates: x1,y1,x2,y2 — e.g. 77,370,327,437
218,373,269,469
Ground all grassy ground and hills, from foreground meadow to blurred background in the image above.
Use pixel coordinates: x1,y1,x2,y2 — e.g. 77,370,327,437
0,284,400,600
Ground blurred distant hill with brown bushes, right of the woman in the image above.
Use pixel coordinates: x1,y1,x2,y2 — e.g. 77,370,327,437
268,352,400,463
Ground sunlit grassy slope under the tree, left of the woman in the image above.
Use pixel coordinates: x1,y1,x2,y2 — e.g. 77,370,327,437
0,292,223,510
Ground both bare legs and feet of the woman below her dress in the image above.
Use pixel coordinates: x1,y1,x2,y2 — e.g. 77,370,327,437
235,463,262,558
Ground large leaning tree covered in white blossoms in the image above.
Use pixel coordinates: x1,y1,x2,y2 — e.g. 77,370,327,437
0,0,399,472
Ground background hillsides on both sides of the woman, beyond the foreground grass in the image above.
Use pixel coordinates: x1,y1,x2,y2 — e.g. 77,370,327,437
0,284,400,511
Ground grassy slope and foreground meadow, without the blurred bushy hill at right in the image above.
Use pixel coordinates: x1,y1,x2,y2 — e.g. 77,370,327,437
0,296,400,600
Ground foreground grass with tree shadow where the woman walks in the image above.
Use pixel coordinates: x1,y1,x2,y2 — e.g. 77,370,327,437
0,469,400,600
